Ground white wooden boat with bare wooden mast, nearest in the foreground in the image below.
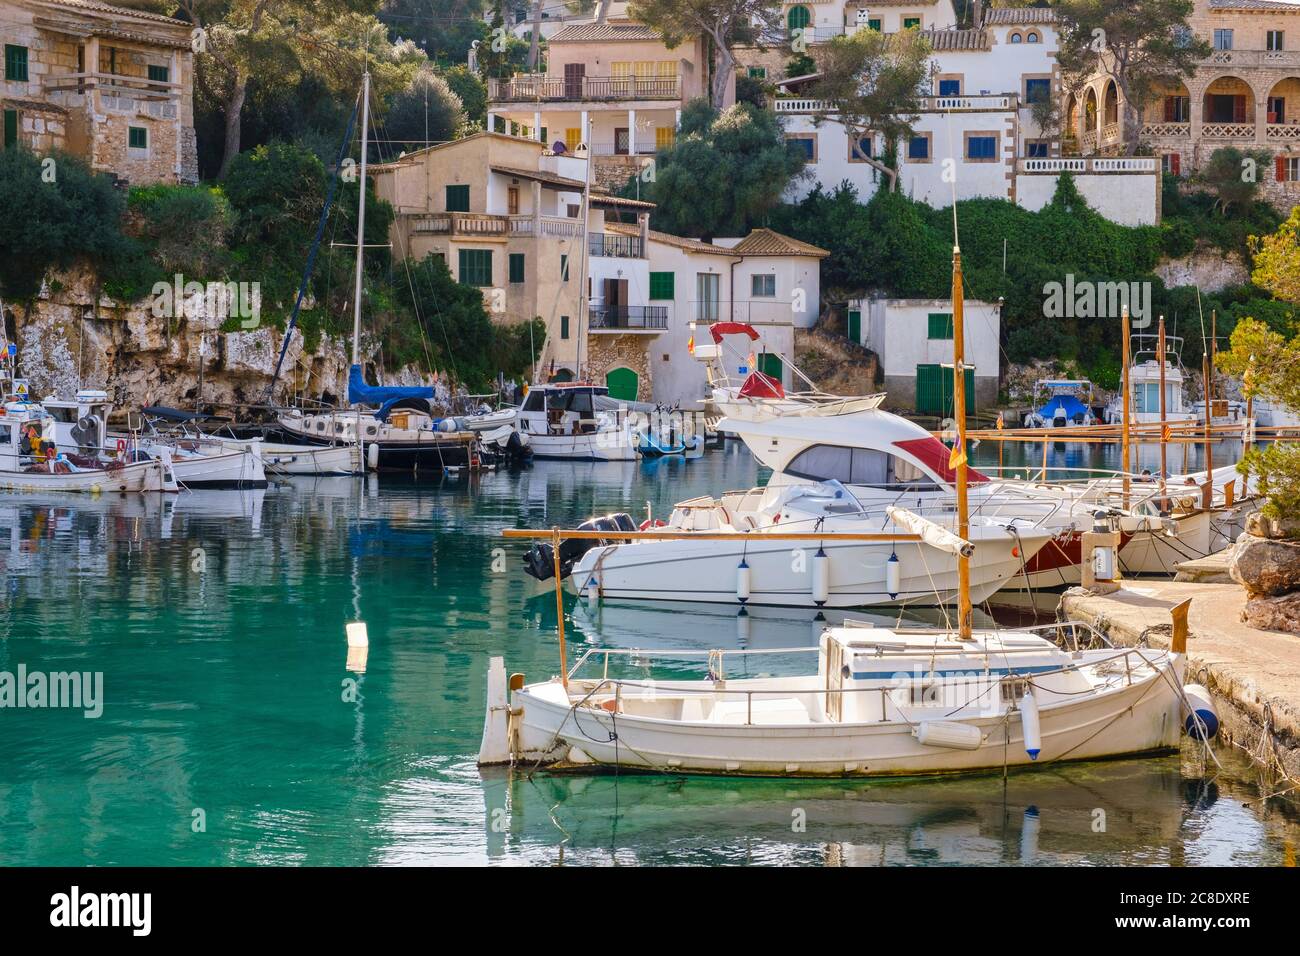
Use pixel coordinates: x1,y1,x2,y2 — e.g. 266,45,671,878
478,239,1216,777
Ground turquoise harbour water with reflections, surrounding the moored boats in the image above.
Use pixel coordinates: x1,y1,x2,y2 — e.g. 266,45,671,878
0,445,1300,865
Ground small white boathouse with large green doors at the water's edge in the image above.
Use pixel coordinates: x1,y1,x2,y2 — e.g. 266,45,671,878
848,293,1002,416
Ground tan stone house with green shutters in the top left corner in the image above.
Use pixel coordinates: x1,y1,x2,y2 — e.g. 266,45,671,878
0,0,199,183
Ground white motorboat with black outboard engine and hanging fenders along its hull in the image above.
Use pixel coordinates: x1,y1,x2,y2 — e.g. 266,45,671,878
525,484,1053,607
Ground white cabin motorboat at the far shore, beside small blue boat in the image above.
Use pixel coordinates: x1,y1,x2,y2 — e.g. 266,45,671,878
519,382,638,462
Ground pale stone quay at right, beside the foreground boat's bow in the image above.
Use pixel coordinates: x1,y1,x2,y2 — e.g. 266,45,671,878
1061,580,1300,782
